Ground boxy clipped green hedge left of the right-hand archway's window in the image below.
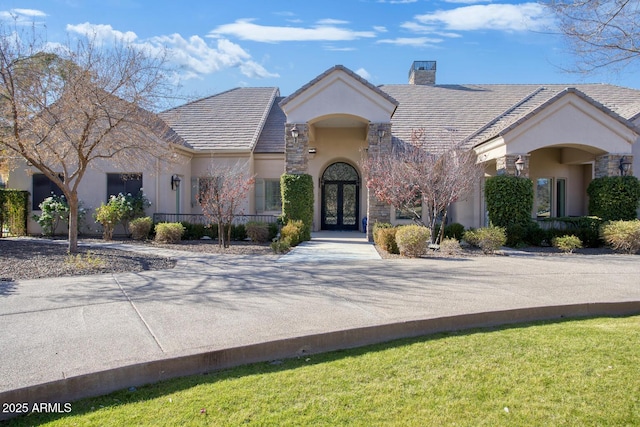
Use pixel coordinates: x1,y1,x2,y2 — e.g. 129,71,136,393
484,175,533,227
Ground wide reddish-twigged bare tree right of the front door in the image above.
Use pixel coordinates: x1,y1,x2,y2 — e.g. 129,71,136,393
362,130,483,243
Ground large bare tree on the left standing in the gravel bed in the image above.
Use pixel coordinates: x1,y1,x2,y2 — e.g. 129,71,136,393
0,27,178,252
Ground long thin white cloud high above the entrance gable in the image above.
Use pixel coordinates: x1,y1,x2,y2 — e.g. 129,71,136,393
209,19,375,43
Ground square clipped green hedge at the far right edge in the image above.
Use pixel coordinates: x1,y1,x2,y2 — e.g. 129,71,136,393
587,176,640,221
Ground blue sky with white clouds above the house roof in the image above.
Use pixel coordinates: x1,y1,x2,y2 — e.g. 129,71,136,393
0,0,640,102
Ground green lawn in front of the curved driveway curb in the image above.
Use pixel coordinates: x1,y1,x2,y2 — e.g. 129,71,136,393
10,316,640,426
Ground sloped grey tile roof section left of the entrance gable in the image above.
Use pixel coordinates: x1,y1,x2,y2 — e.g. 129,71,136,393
159,87,279,151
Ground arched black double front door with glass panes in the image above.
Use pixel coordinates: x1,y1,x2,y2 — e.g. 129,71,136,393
321,162,360,230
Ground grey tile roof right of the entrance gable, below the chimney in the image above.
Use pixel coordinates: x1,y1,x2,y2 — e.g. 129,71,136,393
381,84,640,150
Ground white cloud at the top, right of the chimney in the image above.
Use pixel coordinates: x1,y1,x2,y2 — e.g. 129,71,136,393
415,3,550,31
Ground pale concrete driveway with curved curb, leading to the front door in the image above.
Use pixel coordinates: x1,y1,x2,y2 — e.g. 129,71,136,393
0,234,640,418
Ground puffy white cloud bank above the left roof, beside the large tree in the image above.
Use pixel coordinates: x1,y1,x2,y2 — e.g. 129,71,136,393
67,23,279,80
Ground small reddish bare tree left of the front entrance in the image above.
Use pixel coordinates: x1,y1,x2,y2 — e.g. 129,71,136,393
198,162,255,248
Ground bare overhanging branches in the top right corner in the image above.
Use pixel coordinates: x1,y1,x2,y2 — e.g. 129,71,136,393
545,0,640,73
